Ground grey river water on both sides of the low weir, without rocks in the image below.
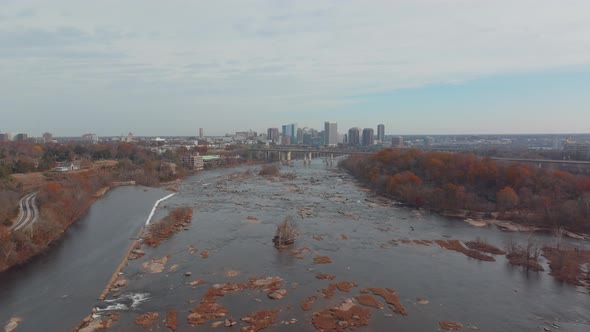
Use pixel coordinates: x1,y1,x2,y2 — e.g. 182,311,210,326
0,160,590,331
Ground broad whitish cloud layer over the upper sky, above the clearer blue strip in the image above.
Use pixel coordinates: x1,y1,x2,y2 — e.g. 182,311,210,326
0,0,590,134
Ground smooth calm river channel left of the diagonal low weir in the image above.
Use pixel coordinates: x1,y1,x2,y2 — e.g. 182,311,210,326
0,187,169,331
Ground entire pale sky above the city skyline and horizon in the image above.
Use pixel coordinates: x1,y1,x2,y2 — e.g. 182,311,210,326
0,0,590,136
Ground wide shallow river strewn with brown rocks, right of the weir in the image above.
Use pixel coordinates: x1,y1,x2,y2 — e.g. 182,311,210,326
73,160,590,331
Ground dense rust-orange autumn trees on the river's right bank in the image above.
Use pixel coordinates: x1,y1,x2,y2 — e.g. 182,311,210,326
340,149,590,231
